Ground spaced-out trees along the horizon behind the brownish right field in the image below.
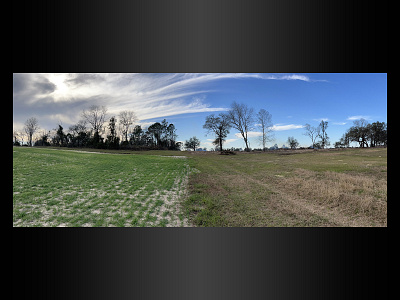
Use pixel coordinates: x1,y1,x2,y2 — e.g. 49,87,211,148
185,102,387,151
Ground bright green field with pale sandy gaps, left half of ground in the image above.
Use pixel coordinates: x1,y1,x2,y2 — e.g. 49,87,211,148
13,147,189,227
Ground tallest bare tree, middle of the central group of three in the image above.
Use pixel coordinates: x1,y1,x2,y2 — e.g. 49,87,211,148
228,101,254,151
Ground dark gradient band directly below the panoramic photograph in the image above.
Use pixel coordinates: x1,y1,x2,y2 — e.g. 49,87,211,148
12,228,387,299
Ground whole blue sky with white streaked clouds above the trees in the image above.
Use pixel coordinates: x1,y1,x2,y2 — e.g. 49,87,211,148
13,73,387,149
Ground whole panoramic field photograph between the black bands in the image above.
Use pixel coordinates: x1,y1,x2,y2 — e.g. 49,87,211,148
13,73,387,227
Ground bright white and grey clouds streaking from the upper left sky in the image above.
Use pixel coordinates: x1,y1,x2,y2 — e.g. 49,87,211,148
13,73,324,131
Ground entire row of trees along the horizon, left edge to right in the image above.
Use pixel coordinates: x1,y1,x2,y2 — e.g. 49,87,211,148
13,101,387,151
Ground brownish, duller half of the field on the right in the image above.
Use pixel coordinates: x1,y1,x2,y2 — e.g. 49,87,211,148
185,148,387,227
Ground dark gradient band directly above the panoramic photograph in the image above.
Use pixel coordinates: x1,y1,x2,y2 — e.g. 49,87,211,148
12,0,388,73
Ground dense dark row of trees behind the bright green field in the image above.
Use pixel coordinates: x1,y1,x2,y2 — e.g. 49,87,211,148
13,105,181,150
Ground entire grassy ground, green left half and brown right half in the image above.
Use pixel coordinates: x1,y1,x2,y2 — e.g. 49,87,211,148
13,147,387,227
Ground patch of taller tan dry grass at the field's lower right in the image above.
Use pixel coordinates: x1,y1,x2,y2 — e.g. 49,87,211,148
274,169,387,226
